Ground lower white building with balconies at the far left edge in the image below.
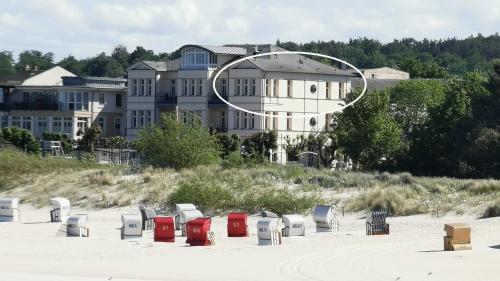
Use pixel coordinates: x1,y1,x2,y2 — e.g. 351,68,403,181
0,66,127,139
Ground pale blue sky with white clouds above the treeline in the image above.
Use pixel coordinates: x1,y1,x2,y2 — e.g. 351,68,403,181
0,0,500,61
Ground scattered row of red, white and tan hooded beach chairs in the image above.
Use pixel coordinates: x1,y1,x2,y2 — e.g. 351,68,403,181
4,197,471,250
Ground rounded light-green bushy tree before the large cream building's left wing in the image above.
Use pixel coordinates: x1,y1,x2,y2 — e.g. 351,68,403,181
135,114,219,169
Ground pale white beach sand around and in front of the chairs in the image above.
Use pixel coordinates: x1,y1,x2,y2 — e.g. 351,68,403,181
0,205,500,281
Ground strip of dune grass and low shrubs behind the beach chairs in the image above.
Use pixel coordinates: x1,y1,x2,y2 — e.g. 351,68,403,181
0,150,500,216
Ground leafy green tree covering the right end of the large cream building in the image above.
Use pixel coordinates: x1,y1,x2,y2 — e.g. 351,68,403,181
336,90,402,169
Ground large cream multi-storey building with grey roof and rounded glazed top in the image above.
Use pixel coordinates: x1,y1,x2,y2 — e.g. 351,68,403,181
127,45,354,163
